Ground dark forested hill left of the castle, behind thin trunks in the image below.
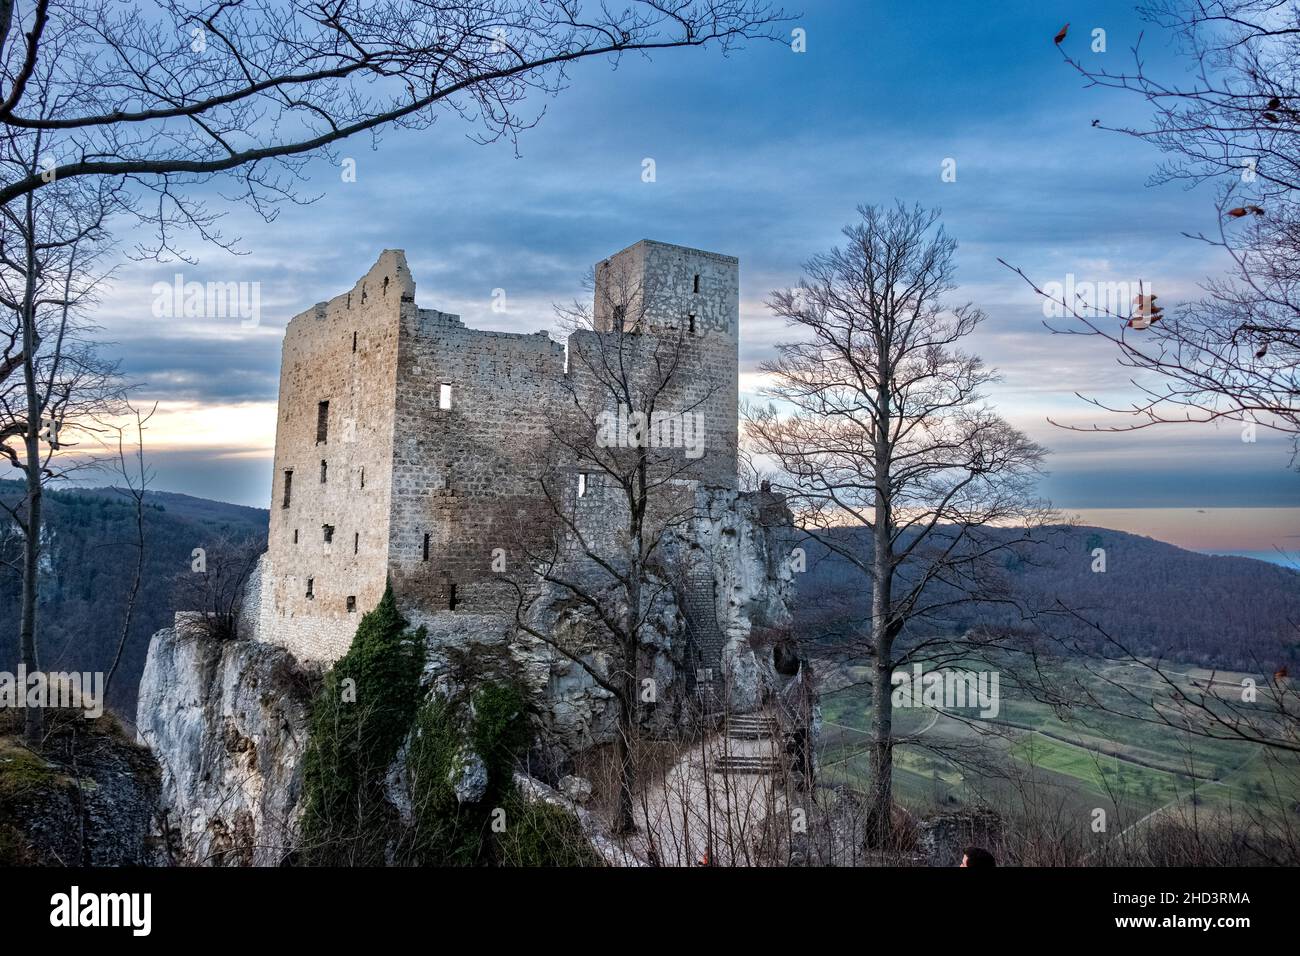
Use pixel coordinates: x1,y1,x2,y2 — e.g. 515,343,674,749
0,481,268,718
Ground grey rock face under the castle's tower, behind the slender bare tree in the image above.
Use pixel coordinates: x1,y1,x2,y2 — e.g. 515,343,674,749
403,488,794,782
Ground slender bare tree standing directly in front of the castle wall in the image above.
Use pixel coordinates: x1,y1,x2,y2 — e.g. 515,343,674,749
512,265,720,831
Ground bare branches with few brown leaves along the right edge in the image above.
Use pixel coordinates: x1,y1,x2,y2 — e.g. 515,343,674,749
1017,0,1300,452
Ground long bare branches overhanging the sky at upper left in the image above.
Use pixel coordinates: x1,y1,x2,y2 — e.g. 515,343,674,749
0,0,783,255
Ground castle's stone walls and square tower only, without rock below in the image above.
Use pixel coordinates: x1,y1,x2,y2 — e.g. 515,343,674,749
259,241,740,661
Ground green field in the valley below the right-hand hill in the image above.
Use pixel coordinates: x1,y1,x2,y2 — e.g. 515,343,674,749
818,662,1300,827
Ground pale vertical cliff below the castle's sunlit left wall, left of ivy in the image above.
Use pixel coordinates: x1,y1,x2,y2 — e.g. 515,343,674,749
137,619,317,865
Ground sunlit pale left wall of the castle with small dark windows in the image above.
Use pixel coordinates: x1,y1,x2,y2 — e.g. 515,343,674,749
259,250,415,661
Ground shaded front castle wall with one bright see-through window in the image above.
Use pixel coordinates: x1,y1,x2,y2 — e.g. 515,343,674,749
389,310,564,611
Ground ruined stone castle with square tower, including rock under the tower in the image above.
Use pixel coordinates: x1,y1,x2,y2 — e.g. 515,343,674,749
248,241,790,750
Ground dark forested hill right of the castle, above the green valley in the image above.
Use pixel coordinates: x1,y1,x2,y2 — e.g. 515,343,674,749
798,527,1300,671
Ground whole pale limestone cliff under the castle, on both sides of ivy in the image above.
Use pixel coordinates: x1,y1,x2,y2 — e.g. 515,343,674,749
137,489,793,865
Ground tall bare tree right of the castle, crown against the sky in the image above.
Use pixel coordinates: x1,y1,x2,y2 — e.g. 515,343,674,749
748,204,1049,847
